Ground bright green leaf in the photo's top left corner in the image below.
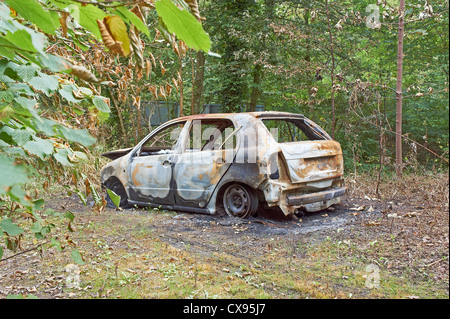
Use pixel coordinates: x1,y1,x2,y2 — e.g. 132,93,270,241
6,0,59,34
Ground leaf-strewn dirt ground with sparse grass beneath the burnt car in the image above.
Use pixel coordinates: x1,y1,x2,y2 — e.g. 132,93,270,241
0,175,449,298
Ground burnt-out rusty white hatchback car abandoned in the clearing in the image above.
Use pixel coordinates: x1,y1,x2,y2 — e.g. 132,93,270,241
101,112,346,218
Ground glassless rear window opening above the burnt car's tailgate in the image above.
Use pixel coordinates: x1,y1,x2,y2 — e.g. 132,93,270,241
261,118,331,143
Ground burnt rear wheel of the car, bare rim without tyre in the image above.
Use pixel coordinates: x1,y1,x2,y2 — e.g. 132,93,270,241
223,184,258,218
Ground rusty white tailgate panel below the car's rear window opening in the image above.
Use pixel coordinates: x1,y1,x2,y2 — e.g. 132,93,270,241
279,140,344,183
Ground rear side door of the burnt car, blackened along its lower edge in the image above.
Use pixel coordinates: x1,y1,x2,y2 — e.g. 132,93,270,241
174,118,239,207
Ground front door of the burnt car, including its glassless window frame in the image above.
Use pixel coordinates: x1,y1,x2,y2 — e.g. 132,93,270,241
128,121,185,204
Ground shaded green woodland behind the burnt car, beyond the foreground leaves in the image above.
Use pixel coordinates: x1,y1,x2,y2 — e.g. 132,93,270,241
100,0,449,172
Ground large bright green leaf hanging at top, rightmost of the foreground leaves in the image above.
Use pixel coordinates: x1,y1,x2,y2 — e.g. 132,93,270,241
155,0,211,52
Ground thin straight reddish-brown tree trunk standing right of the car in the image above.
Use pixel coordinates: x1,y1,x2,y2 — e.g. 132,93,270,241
395,0,405,177
